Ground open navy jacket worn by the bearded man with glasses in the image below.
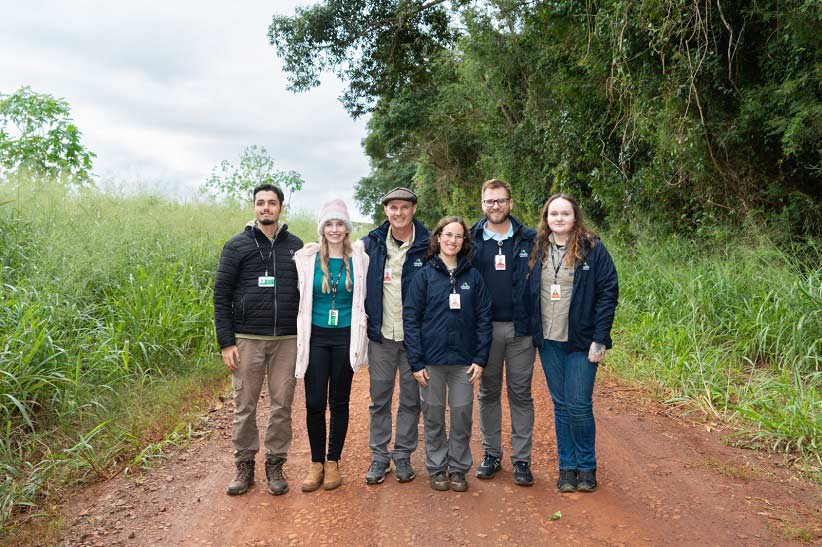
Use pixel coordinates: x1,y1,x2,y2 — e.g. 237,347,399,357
471,215,537,336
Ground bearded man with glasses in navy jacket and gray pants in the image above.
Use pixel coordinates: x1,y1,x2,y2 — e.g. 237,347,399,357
471,179,537,486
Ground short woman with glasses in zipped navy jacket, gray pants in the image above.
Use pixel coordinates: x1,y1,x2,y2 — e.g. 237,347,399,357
402,217,491,492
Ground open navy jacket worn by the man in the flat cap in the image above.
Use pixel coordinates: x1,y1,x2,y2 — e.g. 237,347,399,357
363,219,430,344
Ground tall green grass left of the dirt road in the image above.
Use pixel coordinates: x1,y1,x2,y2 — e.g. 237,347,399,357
0,181,316,534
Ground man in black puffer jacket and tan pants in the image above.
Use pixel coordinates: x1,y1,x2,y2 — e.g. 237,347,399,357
214,184,303,495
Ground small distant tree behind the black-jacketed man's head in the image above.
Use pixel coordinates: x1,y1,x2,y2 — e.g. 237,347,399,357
202,145,305,204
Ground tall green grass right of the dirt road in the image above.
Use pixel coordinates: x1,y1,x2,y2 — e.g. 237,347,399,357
612,228,822,464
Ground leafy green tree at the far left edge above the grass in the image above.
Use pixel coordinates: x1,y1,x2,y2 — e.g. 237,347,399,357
0,87,96,185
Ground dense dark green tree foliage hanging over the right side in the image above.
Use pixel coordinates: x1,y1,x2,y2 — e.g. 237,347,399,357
269,0,822,234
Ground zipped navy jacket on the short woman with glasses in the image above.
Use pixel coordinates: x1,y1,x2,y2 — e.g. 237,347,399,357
402,256,491,372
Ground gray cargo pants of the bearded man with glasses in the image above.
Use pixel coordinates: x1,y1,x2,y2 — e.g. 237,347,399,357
477,321,536,463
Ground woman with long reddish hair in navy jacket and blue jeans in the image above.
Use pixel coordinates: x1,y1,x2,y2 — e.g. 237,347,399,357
529,194,619,492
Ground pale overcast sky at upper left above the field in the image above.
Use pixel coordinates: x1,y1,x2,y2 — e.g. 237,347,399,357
0,0,368,219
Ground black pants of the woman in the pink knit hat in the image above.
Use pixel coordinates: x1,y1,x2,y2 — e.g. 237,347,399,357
305,325,354,462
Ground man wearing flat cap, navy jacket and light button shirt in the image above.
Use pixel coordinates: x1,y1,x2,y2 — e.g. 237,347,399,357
363,186,429,484
